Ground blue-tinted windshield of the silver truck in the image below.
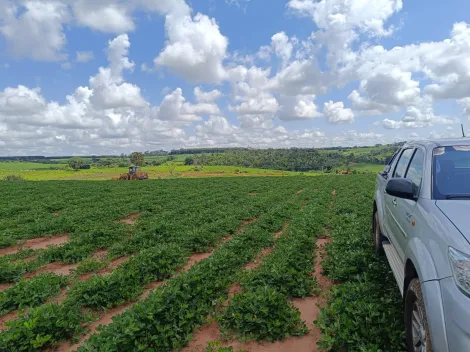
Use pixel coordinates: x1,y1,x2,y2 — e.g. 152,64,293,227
433,146,470,199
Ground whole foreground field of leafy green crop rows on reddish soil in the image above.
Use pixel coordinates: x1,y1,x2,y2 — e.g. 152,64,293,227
0,176,404,352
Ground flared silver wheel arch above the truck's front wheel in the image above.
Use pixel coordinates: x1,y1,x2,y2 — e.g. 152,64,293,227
406,237,439,282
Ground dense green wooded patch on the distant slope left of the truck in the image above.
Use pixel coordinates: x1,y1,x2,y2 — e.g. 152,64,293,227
185,146,397,171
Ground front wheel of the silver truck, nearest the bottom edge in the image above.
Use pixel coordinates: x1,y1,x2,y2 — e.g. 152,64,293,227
405,279,432,352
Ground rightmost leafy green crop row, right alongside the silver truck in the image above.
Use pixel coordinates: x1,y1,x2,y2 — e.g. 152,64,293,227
316,176,405,352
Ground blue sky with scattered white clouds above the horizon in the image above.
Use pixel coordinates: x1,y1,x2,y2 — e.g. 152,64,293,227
0,0,470,156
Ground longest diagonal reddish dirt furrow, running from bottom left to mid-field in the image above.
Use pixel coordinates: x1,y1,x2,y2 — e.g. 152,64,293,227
52,218,258,352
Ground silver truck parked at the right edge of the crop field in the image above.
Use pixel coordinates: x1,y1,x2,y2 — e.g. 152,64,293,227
372,138,470,352
